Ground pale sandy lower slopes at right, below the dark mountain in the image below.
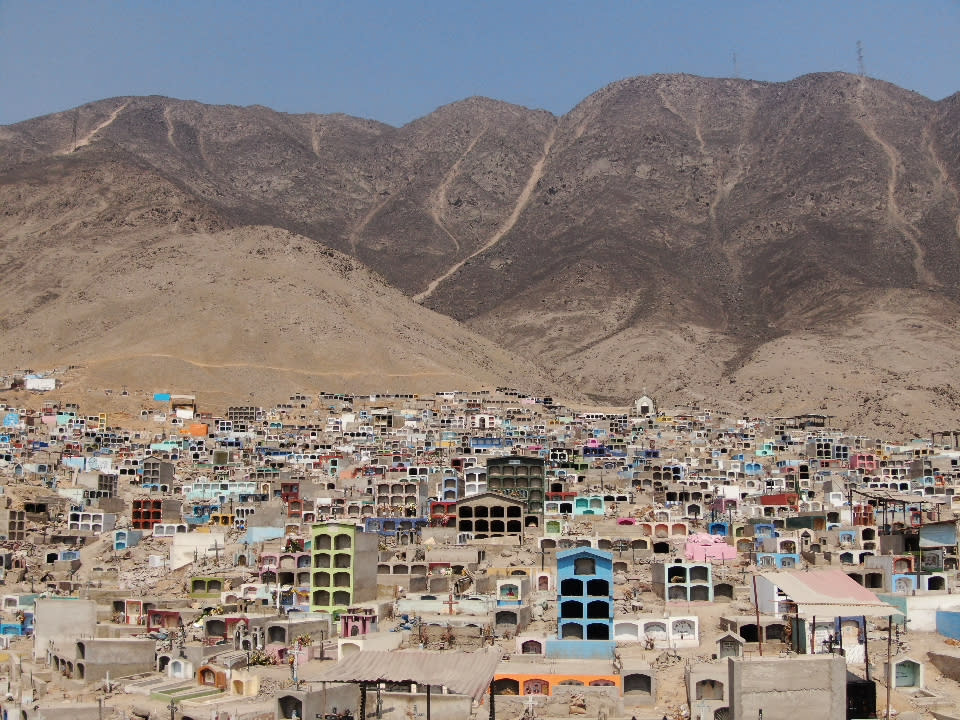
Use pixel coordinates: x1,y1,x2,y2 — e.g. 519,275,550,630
468,291,960,438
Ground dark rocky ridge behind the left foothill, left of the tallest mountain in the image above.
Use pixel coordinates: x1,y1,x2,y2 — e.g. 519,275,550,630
0,97,554,292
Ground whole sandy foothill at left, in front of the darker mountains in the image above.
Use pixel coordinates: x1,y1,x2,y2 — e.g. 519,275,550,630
0,149,556,405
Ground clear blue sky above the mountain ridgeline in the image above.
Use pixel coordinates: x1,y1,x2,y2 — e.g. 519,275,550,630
0,0,960,125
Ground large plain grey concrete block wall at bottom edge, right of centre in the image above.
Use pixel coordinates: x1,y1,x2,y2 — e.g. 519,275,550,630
727,655,847,720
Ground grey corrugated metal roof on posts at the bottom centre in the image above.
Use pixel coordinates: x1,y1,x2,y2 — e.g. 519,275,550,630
317,649,501,702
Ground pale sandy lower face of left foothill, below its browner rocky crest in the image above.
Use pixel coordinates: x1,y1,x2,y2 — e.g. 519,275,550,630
0,227,568,401
